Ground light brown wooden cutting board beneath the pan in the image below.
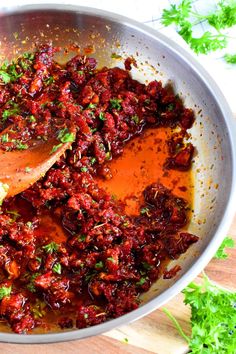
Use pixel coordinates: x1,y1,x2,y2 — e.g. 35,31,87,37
0,216,236,354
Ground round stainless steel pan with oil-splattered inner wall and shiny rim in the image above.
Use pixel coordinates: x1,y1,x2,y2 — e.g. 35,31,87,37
0,4,236,343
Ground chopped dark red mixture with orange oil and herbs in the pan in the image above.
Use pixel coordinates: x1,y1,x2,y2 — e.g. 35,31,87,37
0,45,198,333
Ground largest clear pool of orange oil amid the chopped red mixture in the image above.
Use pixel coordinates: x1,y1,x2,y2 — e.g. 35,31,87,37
98,127,193,215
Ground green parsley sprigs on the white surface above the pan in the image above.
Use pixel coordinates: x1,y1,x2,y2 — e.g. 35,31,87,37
162,0,236,64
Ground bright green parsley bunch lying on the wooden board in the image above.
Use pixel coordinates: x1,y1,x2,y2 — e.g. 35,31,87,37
164,274,236,354
